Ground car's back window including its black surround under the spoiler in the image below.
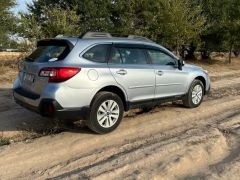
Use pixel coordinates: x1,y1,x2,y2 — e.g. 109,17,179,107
26,40,71,62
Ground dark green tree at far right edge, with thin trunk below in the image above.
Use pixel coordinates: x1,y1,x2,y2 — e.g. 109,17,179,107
201,0,240,62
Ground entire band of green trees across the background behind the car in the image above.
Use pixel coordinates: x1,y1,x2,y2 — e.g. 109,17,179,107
14,0,240,62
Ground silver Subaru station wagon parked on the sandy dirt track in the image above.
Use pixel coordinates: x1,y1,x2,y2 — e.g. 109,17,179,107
13,32,210,133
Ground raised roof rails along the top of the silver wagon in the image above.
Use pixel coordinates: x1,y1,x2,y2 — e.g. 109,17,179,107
79,32,153,42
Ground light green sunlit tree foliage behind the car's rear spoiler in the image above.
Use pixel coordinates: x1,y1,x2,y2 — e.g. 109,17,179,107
18,5,81,40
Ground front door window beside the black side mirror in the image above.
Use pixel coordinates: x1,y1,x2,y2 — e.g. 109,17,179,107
147,50,176,65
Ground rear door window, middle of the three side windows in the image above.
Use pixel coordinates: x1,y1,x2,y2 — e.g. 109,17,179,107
111,48,147,64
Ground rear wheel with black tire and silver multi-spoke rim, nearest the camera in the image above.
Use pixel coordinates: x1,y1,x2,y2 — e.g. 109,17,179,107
86,91,124,134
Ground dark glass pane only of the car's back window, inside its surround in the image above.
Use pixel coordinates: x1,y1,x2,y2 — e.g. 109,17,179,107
26,44,70,62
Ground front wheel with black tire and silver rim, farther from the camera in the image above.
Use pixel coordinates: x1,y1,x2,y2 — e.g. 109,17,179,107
183,79,204,108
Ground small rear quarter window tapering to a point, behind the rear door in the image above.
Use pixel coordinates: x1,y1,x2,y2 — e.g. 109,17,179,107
83,44,109,63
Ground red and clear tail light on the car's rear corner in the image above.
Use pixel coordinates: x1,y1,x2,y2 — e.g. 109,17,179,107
39,67,81,82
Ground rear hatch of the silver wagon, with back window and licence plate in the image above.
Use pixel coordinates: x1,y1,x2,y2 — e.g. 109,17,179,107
19,39,73,94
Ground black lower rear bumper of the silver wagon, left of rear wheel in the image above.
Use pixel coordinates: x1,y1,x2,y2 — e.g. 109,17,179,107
13,89,89,119
